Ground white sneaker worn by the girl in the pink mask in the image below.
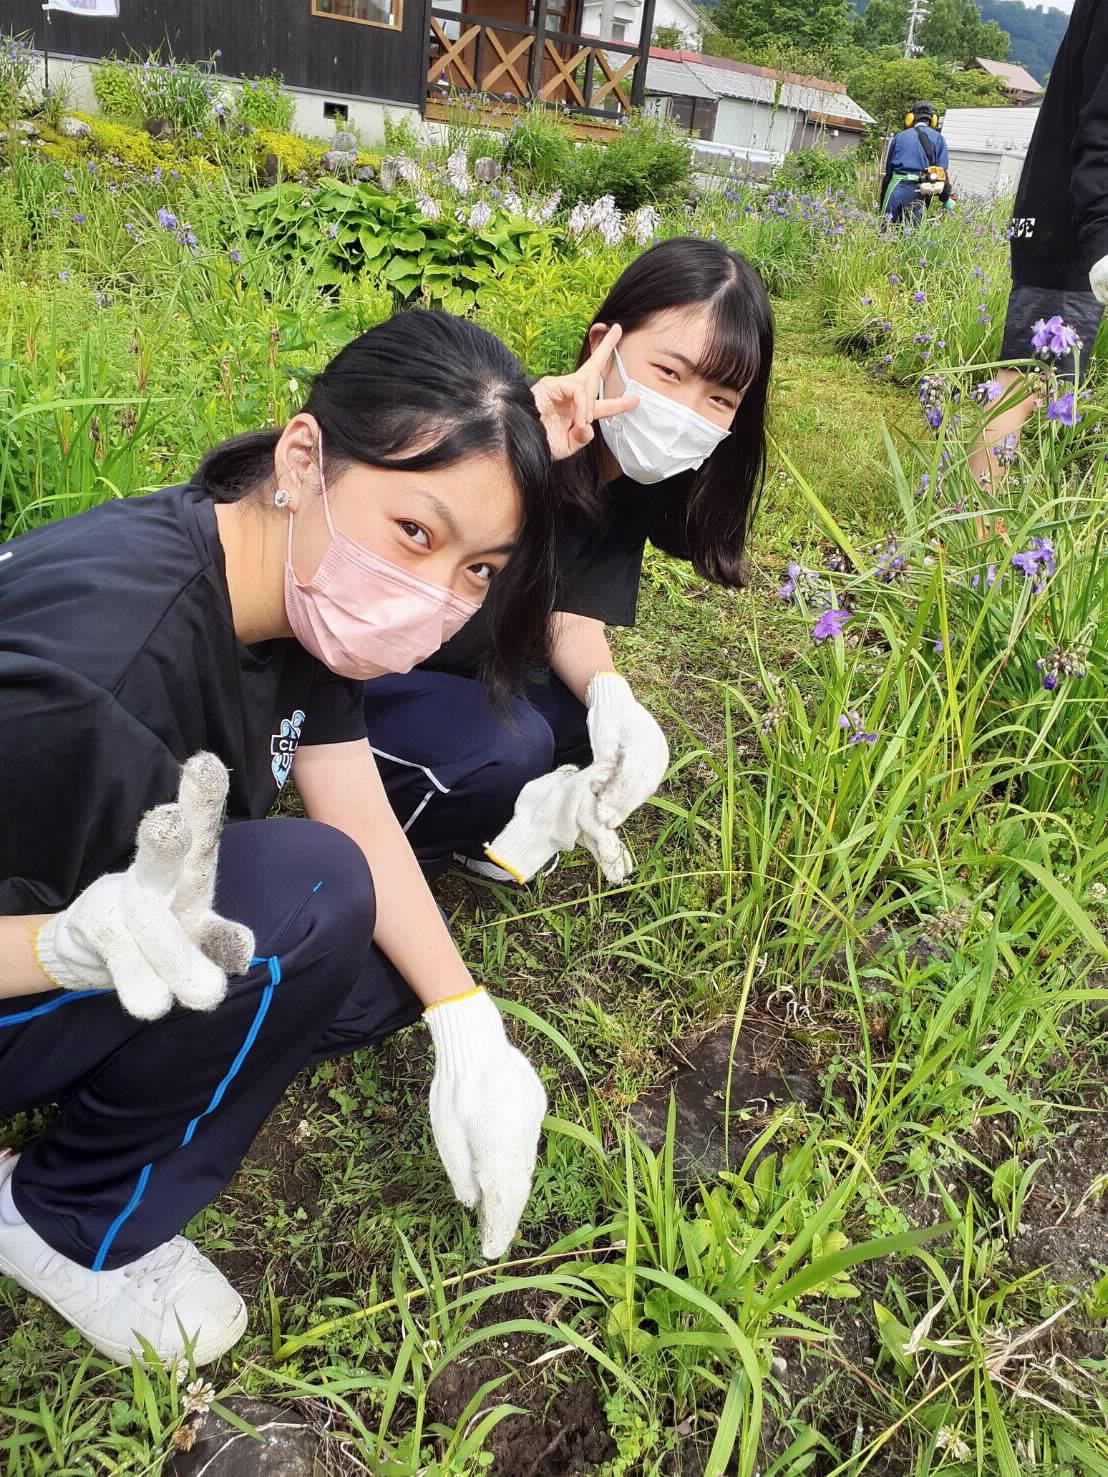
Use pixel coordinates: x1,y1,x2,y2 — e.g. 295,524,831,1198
0,1155,247,1365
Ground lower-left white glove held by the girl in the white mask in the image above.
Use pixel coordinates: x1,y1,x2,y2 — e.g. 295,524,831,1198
485,764,631,882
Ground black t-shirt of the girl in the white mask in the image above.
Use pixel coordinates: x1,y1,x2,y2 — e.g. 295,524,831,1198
423,473,693,676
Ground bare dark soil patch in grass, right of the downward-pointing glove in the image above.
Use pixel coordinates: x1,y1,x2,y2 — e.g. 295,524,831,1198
631,1010,820,1179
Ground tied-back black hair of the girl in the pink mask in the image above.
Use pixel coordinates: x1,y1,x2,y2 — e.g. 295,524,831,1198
194,312,555,697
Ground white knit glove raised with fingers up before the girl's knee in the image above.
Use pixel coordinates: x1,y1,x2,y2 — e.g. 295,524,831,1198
35,753,254,1021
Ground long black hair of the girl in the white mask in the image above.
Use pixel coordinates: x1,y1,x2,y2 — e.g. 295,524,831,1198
554,236,773,588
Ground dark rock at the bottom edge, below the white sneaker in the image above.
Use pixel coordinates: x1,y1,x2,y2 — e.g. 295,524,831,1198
165,1396,322,1477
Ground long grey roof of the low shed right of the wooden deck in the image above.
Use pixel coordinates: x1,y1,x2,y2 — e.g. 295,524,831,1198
646,46,873,124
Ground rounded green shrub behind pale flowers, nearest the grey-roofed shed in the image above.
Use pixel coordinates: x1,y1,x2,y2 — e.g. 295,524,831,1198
563,112,693,210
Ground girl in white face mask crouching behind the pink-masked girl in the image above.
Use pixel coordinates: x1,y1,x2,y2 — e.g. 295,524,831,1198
366,238,773,882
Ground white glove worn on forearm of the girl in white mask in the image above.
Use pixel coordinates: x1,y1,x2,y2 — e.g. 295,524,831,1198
585,672,669,830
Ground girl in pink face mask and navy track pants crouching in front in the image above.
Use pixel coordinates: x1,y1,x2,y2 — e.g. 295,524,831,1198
0,305,628,1363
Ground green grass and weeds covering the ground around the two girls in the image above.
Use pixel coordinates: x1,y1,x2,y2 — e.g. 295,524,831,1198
0,107,1108,1477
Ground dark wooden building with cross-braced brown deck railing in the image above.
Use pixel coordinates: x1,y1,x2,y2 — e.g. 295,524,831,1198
3,0,654,138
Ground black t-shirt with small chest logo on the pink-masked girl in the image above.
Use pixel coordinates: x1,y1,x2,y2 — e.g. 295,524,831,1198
0,486,365,914
